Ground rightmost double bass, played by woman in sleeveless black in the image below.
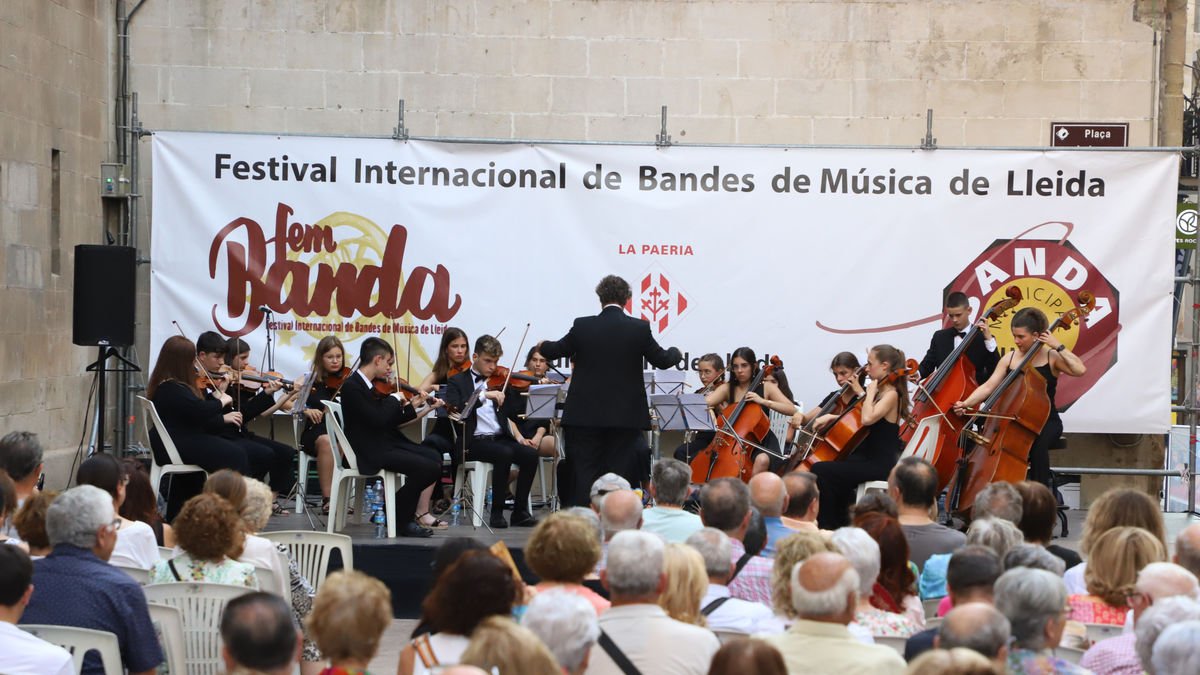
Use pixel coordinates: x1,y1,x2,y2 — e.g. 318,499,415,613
946,291,1096,515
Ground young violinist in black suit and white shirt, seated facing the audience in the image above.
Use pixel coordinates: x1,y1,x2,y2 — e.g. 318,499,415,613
446,335,538,528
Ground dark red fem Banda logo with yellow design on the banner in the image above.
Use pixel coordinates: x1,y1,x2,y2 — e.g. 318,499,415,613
209,202,462,336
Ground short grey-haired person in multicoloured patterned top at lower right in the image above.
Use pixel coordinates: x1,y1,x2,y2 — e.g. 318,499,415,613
995,567,1087,675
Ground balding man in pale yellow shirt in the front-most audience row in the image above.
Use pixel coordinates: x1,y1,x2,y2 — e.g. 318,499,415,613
763,552,905,675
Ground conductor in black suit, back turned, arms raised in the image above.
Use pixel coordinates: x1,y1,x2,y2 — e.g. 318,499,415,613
538,275,683,506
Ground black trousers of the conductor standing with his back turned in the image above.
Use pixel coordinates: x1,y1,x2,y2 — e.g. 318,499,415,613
558,426,650,506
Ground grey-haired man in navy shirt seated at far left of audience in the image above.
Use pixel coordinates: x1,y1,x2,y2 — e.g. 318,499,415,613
22,485,162,675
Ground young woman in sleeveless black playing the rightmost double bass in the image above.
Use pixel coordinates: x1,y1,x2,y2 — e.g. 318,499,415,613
954,307,1087,489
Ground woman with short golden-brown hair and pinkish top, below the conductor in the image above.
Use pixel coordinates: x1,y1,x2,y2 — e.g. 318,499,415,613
524,512,612,615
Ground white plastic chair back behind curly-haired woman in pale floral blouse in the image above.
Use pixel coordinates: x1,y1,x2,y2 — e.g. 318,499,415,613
144,581,251,675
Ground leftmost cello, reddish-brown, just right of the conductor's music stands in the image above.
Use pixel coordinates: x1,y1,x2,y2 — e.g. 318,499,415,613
691,357,784,483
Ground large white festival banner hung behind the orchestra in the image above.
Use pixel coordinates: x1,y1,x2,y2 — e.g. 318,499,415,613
151,132,1177,432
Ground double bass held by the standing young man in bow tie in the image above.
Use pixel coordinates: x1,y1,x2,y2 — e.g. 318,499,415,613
900,285,1024,491
